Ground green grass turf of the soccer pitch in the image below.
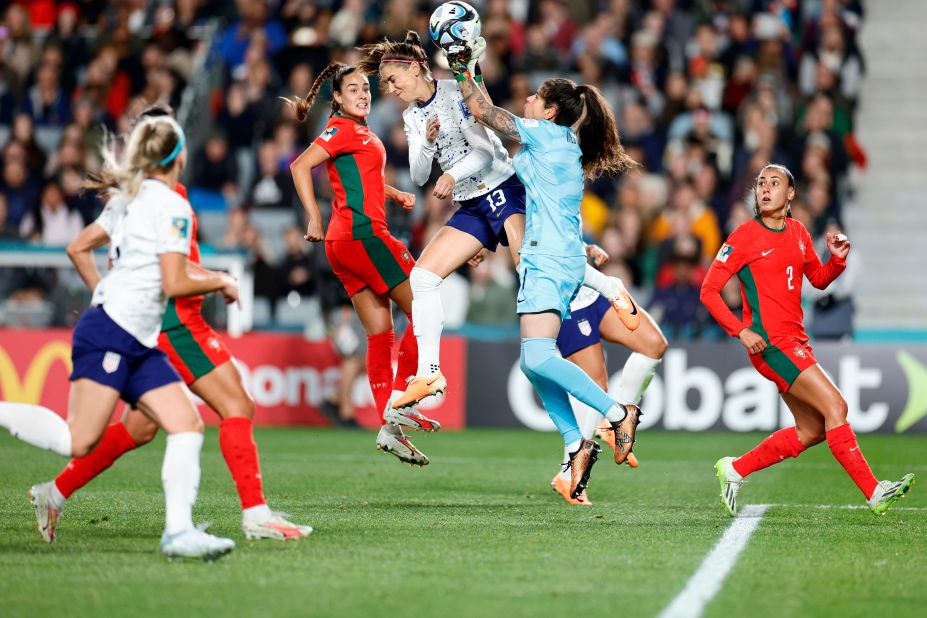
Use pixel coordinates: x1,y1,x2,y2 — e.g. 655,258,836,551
0,429,927,618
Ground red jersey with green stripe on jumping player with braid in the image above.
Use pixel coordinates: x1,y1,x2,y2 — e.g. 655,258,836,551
313,114,389,240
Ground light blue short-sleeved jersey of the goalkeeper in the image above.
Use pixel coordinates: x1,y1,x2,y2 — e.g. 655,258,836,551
512,117,586,257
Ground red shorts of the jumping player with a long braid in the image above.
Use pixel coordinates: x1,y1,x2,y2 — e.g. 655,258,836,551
325,235,415,296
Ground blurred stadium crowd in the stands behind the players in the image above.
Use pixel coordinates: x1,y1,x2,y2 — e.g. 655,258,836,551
0,0,866,338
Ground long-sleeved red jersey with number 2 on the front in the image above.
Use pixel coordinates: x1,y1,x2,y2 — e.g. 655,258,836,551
702,218,846,342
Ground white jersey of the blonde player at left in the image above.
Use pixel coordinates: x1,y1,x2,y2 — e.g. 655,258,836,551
92,179,193,348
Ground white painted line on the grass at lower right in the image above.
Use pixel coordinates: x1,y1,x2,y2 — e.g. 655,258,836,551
658,504,770,618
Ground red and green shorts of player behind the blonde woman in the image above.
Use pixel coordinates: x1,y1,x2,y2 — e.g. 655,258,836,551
158,313,232,386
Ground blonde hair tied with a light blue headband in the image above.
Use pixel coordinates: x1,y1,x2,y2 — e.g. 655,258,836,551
84,116,186,197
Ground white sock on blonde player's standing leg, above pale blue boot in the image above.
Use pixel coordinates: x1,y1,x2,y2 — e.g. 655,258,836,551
161,431,203,534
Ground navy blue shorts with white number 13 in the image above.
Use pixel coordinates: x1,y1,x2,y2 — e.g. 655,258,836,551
447,174,525,251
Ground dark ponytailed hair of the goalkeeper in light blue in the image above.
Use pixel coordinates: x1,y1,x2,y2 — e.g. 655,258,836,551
538,78,637,178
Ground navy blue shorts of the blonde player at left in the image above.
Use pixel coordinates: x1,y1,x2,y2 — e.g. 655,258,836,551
71,307,181,406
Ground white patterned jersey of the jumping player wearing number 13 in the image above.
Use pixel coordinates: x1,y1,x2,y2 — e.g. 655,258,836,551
402,79,515,202
